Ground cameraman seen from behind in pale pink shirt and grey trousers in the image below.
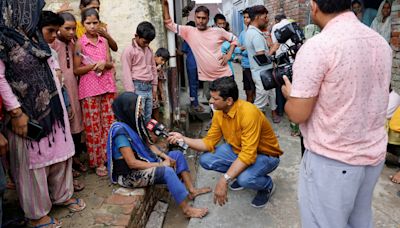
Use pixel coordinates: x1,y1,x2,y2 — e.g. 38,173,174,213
282,0,392,228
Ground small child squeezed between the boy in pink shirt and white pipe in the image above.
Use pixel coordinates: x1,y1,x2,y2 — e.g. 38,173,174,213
153,48,170,121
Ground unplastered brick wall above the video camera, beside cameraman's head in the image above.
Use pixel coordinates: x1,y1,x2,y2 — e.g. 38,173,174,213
265,0,308,26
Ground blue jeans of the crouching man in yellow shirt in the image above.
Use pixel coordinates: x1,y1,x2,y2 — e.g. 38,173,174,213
200,144,280,191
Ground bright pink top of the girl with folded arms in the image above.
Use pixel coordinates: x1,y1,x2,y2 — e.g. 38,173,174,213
78,35,117,100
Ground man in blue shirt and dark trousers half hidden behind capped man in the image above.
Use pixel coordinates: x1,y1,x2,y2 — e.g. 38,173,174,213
236,8,256,103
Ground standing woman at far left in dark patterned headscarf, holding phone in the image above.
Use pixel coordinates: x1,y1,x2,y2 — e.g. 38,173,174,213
0,0,85,227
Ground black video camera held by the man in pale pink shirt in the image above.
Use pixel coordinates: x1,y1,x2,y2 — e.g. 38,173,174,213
260,22,305,90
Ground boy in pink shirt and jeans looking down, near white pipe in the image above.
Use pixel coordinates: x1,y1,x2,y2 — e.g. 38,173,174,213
121,21,158,123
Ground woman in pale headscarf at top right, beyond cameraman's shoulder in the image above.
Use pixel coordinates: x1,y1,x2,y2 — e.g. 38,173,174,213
371,0,392,42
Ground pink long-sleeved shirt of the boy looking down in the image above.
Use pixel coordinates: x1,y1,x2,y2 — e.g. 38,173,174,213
121,39,158,92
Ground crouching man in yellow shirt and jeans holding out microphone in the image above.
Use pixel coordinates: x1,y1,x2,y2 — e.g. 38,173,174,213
168,77,283,207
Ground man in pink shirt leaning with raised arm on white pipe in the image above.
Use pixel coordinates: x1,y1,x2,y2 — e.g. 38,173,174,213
162,0,237,98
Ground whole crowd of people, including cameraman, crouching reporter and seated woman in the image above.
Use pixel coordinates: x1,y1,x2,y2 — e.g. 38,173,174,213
0,0,400,228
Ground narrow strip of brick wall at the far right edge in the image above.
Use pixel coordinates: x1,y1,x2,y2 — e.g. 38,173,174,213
390,0,400,93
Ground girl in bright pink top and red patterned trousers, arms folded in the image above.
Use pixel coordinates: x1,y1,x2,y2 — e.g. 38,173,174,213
74,8,116,176
